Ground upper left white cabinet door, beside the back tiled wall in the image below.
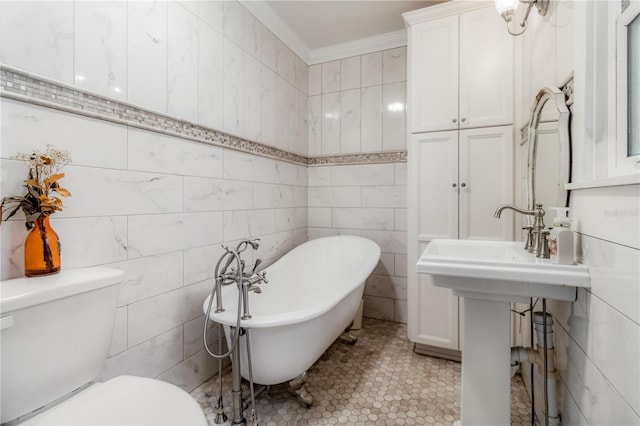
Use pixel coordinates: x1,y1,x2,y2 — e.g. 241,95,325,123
409,16,460,133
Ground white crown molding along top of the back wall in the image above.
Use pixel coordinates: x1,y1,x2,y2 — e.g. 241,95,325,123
307,30,407,65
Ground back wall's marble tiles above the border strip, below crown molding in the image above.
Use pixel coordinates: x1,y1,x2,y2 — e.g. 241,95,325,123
308,47,407,156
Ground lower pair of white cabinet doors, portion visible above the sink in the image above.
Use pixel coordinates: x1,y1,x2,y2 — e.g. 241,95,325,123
410,126,513,243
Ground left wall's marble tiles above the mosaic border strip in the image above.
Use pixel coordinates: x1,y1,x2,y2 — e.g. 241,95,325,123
0,0,308,155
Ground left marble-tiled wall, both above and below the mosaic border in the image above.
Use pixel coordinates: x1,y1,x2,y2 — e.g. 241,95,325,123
0,1,308,390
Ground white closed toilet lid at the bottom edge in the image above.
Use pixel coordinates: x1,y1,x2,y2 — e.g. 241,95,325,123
24,376,207,426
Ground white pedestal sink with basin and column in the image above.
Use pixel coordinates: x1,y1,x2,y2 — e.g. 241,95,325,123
416,240,590,426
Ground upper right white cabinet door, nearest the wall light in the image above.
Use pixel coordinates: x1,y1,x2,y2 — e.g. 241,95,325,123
458,7,514,129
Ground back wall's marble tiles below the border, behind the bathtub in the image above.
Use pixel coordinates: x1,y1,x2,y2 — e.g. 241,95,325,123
308,162,407,323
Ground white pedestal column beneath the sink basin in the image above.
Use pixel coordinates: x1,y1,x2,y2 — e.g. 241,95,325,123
460,294,511,426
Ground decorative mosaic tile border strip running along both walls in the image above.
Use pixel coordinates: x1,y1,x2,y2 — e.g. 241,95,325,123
0,64,407,166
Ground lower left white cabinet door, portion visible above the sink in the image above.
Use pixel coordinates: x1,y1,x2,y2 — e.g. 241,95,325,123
411,130,459,241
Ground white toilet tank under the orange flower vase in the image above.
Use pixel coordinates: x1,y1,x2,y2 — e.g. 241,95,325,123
0,267,123,423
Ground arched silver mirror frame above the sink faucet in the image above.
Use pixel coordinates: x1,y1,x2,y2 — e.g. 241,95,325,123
527,86,571,210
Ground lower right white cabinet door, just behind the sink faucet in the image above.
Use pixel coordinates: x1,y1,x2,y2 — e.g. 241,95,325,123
459,126,513,240
